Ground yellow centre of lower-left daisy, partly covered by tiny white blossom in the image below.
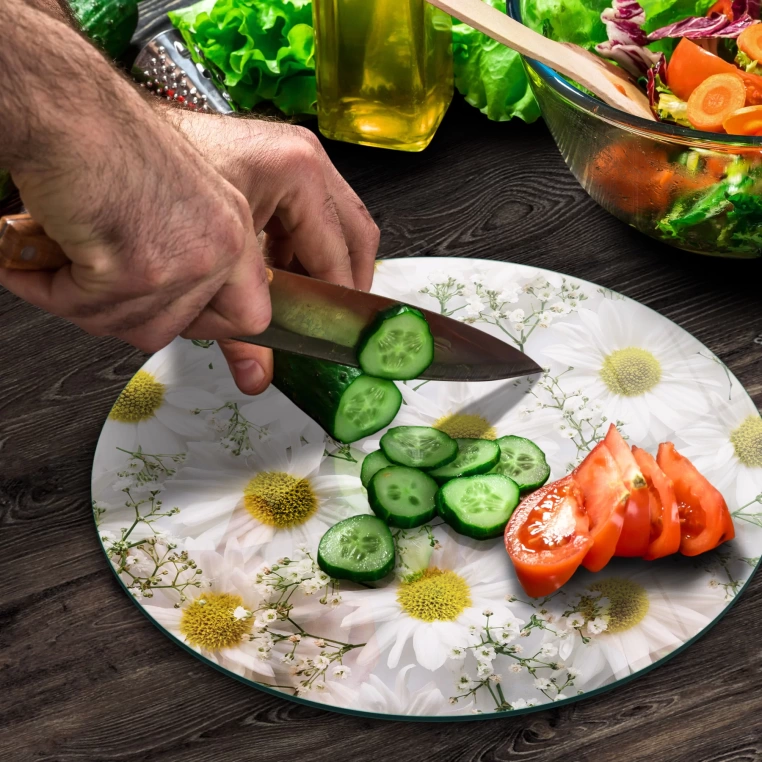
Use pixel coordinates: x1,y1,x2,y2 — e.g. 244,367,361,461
180,593,252,651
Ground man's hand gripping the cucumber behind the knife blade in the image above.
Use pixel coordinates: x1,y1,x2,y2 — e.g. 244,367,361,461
165,108,379,382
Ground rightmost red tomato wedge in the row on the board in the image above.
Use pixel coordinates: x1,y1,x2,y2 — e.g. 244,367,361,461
656,442,735,556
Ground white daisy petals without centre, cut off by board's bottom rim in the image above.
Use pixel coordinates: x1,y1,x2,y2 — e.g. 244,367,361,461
319,664,473,717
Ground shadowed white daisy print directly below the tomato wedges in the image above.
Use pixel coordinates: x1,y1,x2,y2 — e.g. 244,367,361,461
562,569,725,690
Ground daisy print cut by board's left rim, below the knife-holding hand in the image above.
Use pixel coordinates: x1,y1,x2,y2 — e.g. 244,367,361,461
96,343,221,471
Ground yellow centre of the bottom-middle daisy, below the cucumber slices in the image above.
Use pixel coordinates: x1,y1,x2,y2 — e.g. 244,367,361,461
397,566,471,622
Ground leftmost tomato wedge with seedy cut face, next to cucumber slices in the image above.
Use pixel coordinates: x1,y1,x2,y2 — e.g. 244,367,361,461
505,476,592,598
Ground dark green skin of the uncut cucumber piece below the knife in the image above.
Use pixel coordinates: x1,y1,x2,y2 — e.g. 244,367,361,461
273,350,402,444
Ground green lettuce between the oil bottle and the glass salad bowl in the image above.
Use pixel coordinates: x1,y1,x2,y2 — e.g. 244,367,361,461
452,0,540,122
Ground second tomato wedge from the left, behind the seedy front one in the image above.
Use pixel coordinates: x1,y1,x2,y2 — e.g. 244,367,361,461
574,442,630,571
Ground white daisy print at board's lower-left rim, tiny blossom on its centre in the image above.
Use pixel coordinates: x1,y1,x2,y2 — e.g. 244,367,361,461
143,541,274,677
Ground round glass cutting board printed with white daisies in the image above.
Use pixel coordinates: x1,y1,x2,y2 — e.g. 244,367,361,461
92,258,762,720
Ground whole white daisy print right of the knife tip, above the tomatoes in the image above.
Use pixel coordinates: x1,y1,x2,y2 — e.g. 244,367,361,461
543,300,718,442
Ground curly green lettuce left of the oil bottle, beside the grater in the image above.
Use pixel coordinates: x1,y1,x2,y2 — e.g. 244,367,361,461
169,0,317,115
